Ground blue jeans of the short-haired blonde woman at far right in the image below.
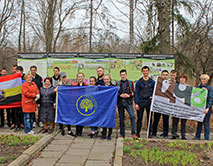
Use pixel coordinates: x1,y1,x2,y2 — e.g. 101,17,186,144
195,108,212,140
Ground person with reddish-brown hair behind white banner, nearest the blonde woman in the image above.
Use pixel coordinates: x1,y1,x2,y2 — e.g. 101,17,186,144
172,73,188,140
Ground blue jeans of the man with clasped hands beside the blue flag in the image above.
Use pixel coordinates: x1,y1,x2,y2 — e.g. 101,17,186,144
118,102,135,137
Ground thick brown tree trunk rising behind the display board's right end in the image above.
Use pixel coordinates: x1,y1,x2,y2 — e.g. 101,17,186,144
156,0,170,54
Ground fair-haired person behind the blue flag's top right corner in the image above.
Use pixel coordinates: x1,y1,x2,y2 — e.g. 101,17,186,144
101,74,113,140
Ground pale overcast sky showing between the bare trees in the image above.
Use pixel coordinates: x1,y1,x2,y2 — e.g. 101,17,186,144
0,0,213,48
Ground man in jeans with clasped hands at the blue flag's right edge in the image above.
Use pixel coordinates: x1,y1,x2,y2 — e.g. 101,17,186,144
116,69,137,139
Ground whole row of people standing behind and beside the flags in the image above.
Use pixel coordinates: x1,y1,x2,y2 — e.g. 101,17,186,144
0,65,213,140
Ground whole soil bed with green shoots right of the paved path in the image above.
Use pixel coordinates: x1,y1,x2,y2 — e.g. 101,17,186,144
123,139,213,166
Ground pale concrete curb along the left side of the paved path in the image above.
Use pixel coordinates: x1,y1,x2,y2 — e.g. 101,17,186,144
8,132,58,166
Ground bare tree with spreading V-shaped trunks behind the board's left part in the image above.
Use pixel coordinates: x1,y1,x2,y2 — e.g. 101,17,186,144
28,0,81,52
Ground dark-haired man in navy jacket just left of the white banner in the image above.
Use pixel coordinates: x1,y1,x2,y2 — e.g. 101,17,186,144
135,66,155,137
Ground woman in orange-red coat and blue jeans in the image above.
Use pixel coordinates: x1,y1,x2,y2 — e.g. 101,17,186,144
21,74,40,134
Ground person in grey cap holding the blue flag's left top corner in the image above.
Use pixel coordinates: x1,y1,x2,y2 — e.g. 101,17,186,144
55,72,76,137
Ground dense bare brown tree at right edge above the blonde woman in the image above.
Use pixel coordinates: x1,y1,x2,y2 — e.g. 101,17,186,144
177,0,213,84
